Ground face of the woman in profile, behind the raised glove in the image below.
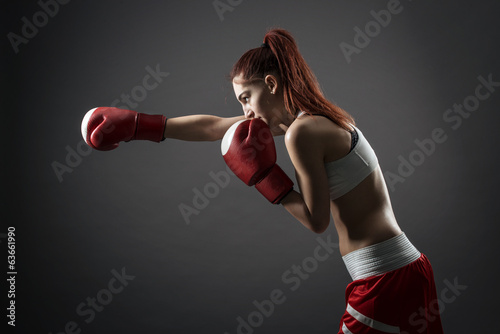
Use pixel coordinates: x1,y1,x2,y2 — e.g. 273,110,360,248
233,75,293,135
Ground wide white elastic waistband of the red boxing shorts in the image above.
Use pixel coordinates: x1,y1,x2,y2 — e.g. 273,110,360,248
342,233,420,281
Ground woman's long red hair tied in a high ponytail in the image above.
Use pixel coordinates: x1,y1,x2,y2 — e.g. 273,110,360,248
230,29,355,130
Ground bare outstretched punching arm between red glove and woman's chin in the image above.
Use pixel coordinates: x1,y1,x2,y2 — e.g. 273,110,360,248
163,115,245,141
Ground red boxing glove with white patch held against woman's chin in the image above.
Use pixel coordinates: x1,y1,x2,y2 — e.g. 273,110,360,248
221,118,293,204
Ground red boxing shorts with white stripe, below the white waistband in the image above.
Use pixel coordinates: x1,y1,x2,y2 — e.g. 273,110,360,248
339,254,443,334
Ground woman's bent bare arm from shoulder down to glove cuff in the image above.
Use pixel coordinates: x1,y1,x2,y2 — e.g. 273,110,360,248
281,123,330,233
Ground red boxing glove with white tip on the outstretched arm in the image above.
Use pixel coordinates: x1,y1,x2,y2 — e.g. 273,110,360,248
82,107,167,151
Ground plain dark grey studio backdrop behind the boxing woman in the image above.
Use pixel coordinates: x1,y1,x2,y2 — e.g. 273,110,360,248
0,0,500,334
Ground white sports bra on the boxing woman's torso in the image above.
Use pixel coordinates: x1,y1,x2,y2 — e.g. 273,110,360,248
297,112,378,200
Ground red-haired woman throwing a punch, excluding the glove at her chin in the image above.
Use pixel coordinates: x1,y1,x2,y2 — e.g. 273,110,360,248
82,29,442,334
